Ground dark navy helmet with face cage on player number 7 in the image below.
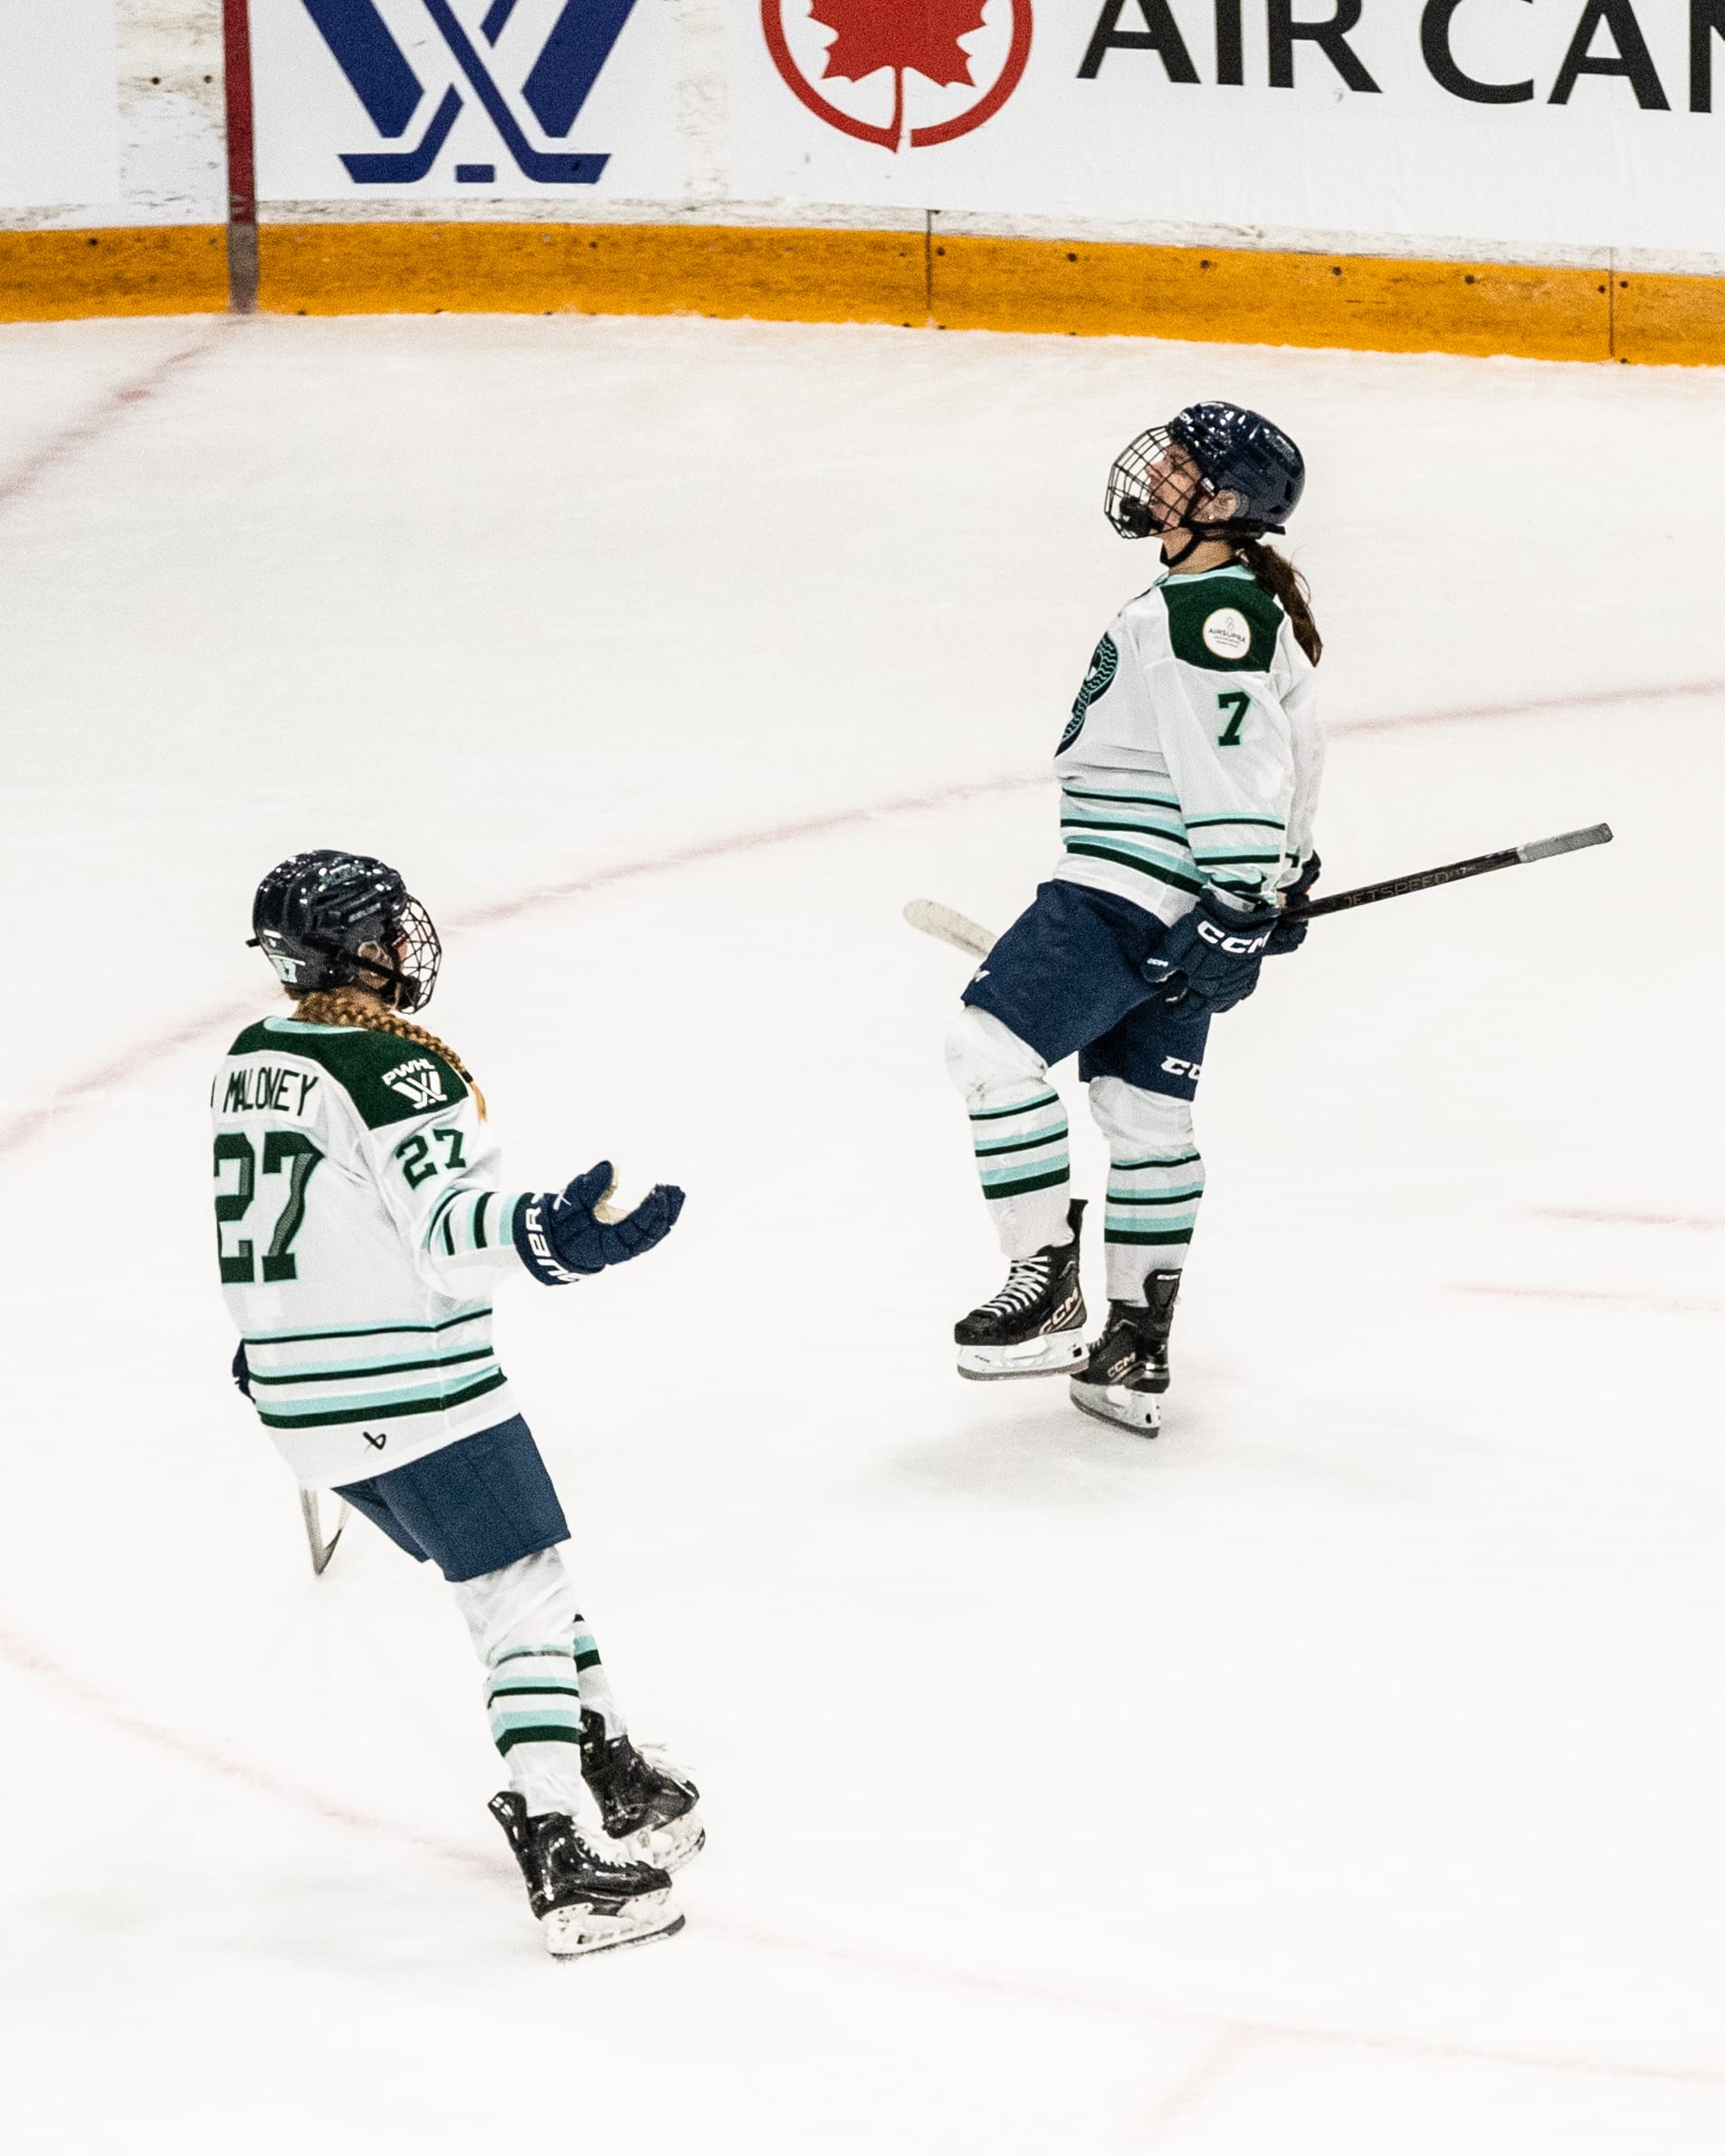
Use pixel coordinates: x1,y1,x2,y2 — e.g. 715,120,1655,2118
1101,403,1307,546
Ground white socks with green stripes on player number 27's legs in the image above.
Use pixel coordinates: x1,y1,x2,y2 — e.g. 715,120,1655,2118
451,1550,624,1816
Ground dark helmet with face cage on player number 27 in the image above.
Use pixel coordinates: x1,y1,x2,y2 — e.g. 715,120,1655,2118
250,845,442,1011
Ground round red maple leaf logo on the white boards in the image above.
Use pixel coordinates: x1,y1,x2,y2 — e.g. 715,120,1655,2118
761,0,1031,151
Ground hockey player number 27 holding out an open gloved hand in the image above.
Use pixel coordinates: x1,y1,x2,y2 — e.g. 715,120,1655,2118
211,852,703,1955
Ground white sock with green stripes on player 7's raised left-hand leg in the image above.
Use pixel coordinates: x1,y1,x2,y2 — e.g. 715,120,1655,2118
947,1005,1072,1259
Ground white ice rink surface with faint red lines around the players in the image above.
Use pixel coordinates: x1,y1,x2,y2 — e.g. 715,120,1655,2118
0,317,1725,2156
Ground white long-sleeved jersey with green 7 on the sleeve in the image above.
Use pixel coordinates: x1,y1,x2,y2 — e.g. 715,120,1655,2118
1054,563,1324,922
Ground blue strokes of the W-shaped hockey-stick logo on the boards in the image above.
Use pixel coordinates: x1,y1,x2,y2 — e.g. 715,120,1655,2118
306,0,634,187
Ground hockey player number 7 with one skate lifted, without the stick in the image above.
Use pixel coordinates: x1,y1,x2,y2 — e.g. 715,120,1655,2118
947,403,1324,1434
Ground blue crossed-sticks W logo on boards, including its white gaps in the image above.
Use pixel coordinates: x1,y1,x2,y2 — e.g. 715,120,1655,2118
304,0,636,187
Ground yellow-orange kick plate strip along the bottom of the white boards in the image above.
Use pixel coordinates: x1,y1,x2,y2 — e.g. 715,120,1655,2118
0,220,1725,367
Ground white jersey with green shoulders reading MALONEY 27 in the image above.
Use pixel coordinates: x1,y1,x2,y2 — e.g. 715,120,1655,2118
209,1017,524,1488
